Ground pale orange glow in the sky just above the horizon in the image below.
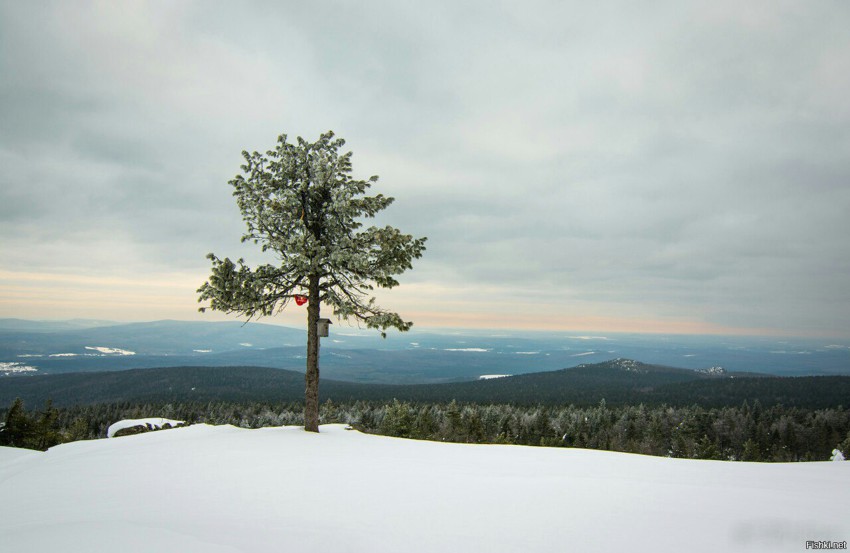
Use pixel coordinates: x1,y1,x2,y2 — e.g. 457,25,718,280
0,270,828,336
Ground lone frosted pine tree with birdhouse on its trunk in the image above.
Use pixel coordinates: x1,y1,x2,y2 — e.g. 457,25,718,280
198,132,426,432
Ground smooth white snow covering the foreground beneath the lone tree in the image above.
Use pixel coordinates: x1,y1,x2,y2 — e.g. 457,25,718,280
0,425,850,553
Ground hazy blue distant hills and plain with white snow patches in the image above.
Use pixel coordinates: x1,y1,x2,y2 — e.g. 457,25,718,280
0,319,850,384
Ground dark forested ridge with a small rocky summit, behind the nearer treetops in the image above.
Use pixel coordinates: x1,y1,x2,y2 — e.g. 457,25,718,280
0,359,850,409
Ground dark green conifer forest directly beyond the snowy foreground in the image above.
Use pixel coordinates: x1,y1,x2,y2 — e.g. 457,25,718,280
0,400,850,462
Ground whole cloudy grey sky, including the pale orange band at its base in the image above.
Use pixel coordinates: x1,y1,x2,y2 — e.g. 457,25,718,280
0,0,850,338
